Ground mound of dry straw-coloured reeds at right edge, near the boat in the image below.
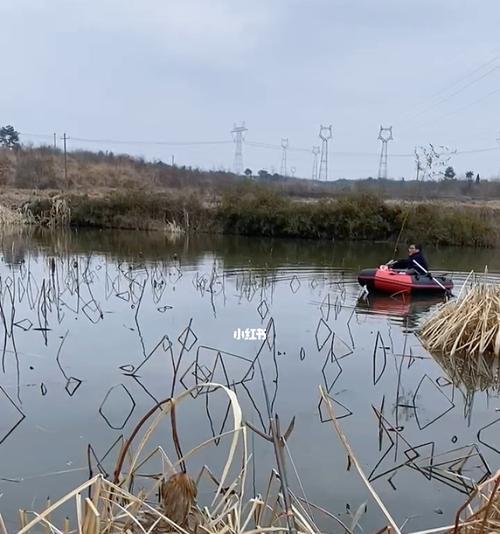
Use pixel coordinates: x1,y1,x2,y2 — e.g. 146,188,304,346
420,280,500,358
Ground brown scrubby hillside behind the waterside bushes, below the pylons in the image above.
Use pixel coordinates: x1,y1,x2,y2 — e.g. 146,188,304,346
0,147,500,200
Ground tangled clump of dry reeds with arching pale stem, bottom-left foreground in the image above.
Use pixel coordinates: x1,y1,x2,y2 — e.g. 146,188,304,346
6,384,318,534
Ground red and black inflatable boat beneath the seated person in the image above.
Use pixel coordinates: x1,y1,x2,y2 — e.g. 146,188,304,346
358,265,453,294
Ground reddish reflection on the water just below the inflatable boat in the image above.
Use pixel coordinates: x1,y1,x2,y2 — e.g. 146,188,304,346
356,293,443,326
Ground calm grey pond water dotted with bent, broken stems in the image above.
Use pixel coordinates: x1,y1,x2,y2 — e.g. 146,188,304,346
0,232,500,531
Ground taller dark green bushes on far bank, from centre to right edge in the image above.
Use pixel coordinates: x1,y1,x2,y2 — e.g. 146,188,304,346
217,186,500,247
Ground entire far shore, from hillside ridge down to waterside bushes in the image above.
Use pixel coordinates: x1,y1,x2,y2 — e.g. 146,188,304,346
0,147,500,247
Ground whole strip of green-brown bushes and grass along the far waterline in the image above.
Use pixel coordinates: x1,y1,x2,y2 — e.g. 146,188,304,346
12,185,500,247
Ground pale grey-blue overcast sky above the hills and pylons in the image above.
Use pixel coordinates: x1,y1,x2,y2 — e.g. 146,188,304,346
0,0,500,179
